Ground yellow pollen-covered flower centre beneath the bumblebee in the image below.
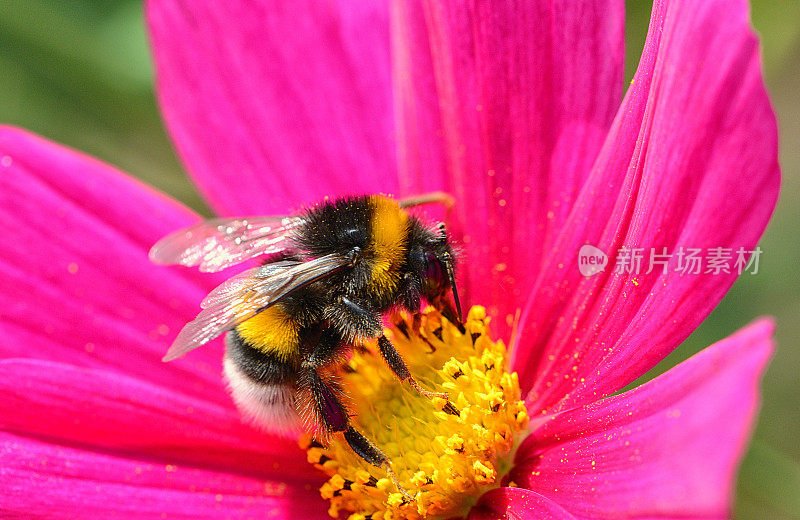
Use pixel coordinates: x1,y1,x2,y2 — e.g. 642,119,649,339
301,307,528,520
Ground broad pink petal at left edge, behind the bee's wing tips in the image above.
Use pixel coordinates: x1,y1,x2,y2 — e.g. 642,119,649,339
0,128,229,403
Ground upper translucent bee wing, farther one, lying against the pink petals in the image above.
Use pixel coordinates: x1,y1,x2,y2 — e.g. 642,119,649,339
150,217,304,272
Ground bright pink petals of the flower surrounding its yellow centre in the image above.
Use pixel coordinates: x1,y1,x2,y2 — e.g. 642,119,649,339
0,0,779,519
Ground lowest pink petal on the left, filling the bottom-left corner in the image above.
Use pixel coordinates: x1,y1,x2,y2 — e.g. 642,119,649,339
0,432,327,520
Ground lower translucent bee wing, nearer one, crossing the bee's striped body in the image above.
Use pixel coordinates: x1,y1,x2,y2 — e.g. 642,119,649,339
164,255,351,361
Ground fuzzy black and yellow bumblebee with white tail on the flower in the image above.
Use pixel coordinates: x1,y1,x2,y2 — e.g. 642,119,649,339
150,194,462,475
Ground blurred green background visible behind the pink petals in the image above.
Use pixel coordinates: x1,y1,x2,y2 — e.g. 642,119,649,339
0,0,800,520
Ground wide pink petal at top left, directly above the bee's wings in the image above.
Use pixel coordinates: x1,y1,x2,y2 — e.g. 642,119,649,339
147,0,397,215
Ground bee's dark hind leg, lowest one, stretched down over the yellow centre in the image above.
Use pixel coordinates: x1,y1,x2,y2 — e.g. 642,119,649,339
308,369,413,500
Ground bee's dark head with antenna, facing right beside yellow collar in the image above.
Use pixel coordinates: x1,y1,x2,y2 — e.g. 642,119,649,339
411,224,462,321
